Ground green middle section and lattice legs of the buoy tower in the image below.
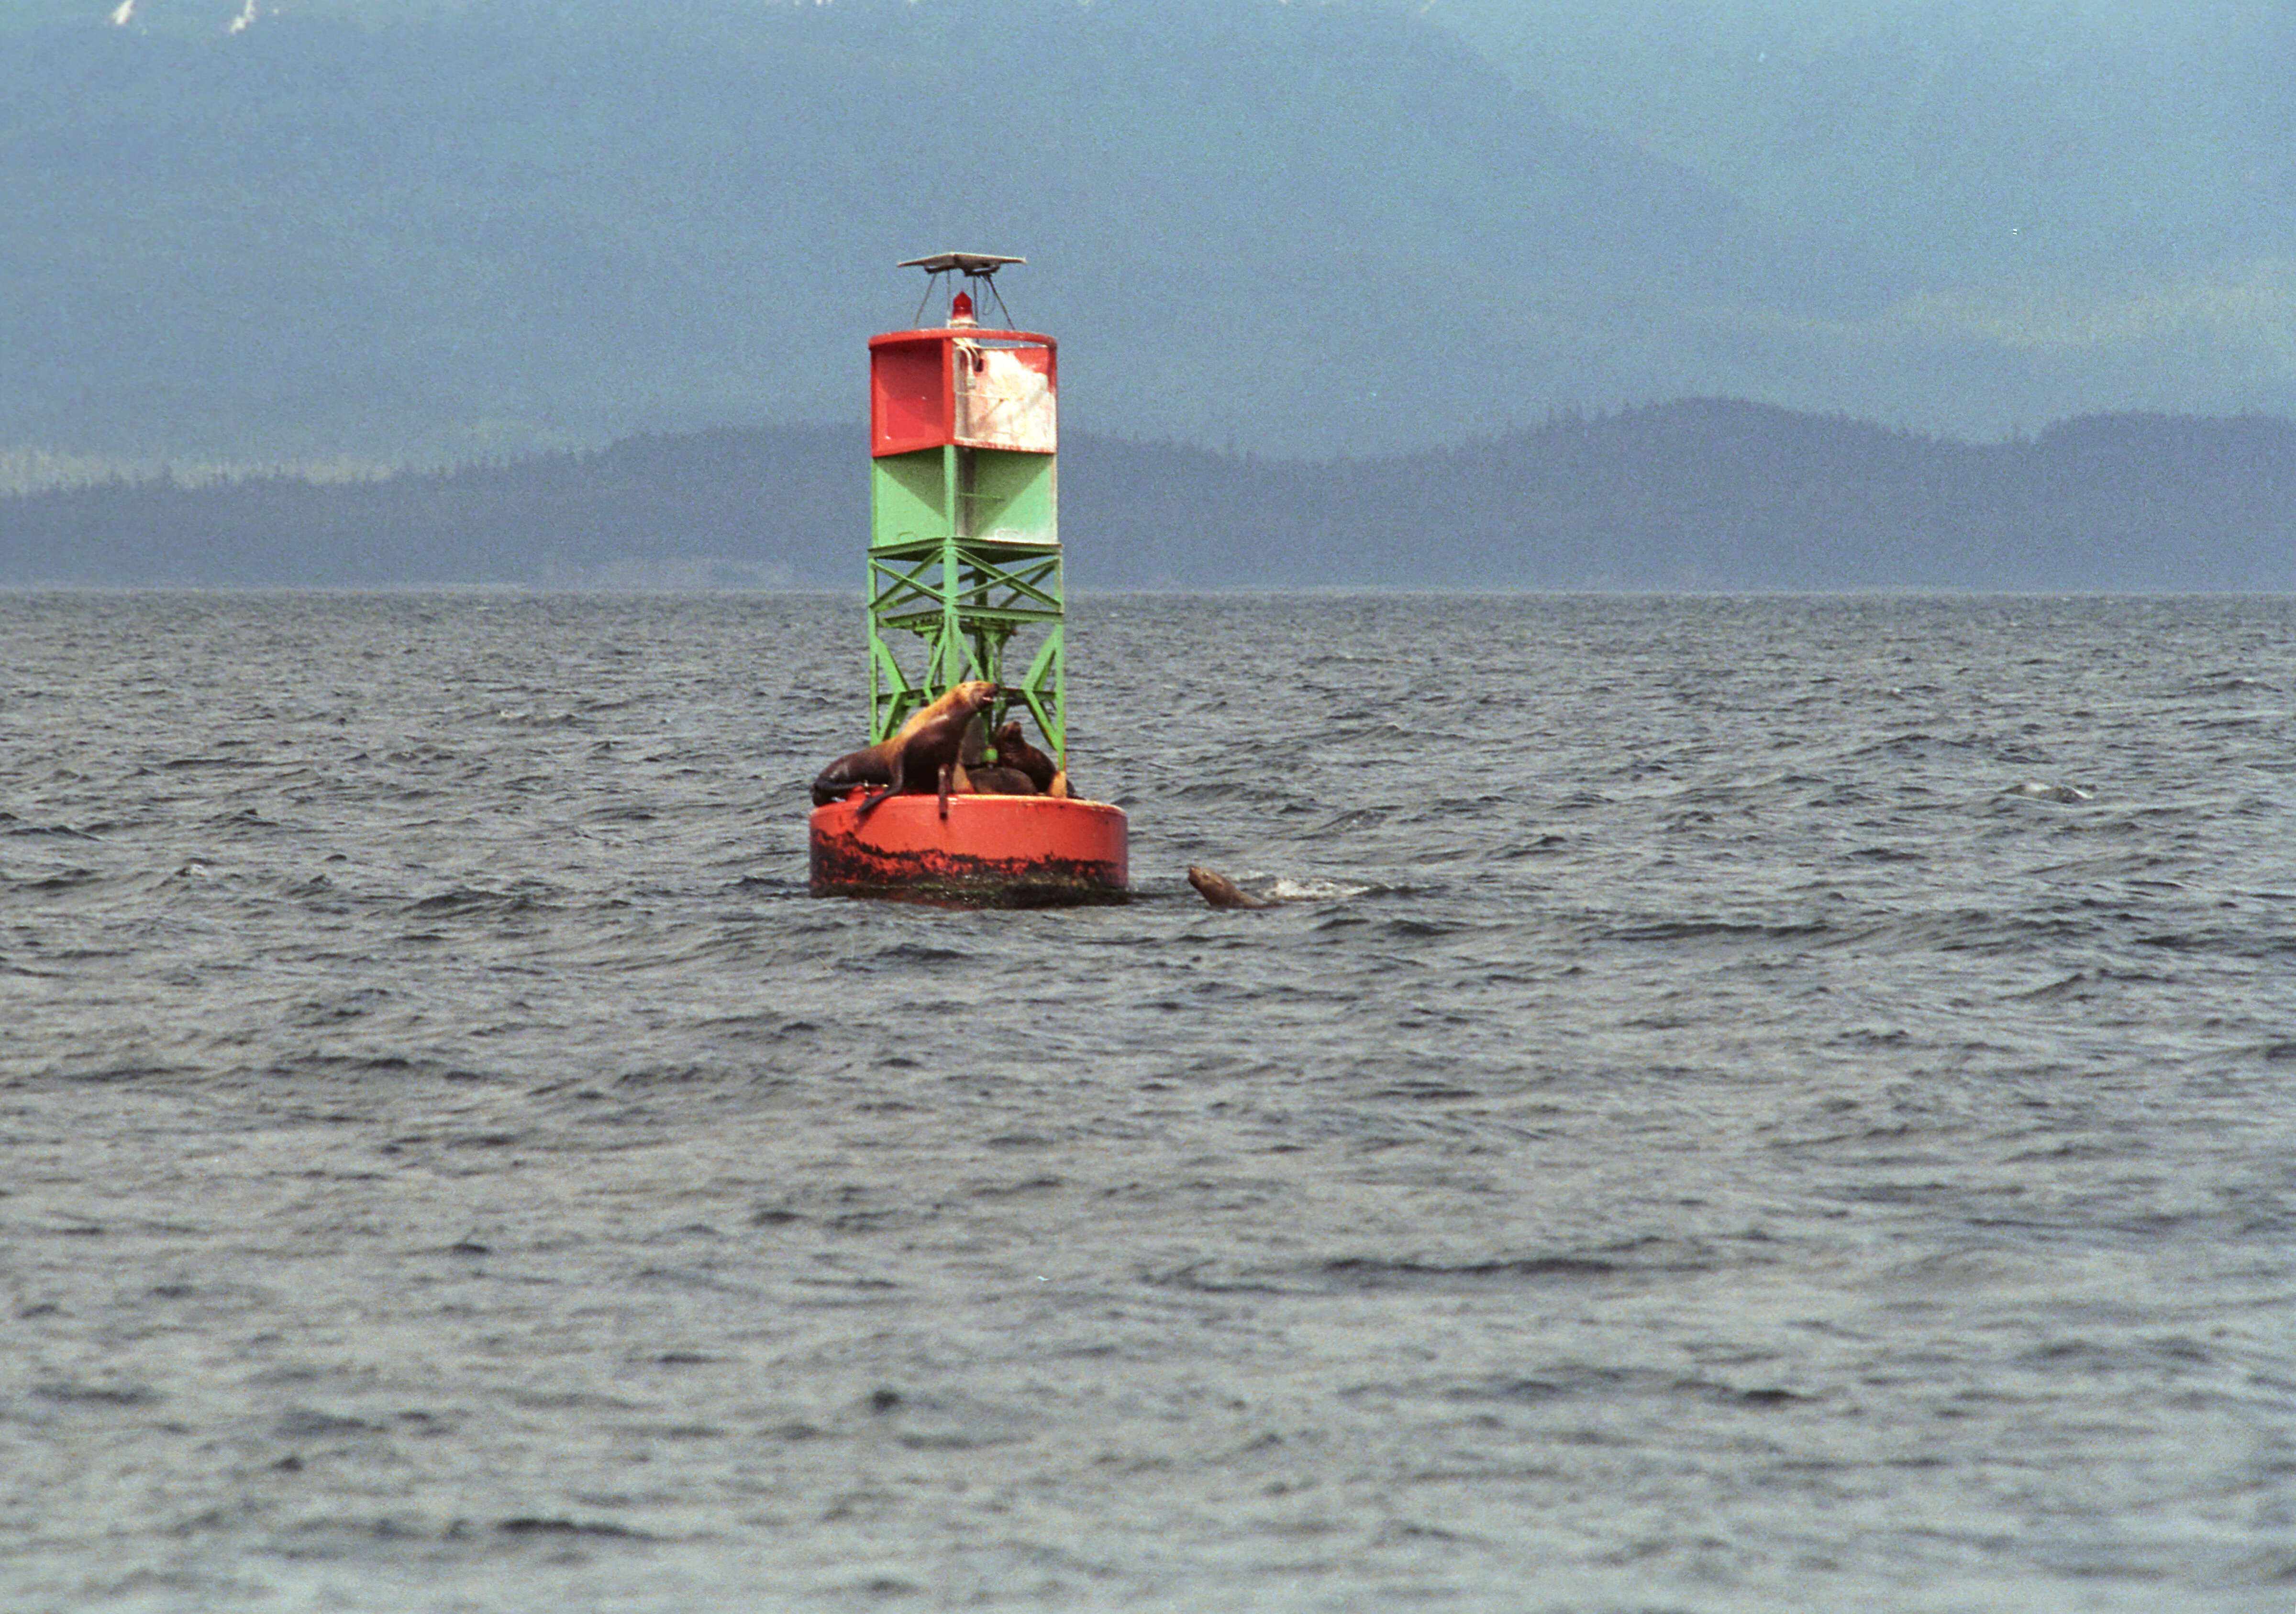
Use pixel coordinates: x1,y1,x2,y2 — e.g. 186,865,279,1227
868,443,1068,767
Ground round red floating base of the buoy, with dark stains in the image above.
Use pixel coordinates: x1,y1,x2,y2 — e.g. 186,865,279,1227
813,795,1130,907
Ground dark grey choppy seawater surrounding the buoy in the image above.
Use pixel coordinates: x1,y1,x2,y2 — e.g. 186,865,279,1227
0,597,2296,1614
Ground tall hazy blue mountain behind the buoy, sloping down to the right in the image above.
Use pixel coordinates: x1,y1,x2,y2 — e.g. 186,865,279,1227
0,0,1809,462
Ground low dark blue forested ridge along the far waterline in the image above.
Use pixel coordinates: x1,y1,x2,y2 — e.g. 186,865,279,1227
0,399,2296,592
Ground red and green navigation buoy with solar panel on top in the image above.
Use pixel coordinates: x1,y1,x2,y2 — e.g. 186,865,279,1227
810,253,1127,907
